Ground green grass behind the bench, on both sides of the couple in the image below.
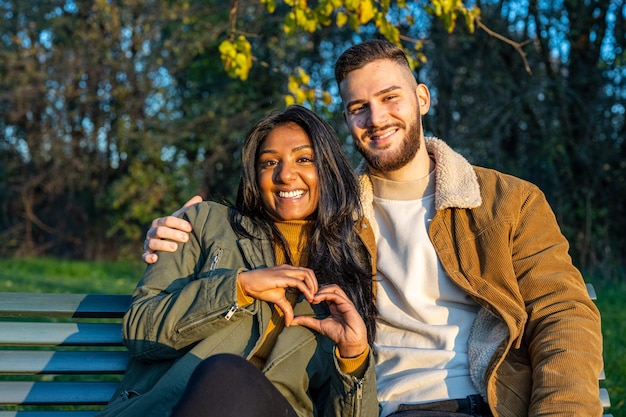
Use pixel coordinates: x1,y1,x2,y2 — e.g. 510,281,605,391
0,259,626,417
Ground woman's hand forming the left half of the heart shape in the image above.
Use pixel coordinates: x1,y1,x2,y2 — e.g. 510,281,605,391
237,265,317,326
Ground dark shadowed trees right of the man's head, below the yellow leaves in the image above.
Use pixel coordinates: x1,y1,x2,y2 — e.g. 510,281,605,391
423,1,626,271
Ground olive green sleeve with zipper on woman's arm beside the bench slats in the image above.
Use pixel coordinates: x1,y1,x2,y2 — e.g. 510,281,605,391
123,203,256,360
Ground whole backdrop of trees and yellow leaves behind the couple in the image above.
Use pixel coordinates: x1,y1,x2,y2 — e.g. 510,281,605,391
0,0,626,270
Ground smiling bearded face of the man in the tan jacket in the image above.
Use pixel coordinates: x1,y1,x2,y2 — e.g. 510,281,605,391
340,60,430,172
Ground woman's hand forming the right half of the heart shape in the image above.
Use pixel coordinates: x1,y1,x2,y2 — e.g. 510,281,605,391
292,284,368,358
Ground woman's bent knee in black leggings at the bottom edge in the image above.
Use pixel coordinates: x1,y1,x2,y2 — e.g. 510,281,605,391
172,354,297,417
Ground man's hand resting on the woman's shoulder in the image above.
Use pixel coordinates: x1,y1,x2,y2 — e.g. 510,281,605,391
141,195,202,264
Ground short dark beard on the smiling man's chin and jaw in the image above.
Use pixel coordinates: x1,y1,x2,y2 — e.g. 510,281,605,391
354,118,420,172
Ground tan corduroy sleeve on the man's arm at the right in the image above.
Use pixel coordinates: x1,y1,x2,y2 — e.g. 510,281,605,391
512,185,603,416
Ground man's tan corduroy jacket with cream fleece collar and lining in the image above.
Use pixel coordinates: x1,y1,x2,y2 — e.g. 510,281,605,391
359,138,603,417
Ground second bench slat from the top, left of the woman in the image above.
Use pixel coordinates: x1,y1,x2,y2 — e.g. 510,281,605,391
0,322,122,346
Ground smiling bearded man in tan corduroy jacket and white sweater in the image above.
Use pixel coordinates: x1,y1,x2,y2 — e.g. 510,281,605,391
144,41,602,417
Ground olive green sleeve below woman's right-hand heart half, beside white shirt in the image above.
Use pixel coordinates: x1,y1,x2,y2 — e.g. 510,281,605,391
323,349,379,417
